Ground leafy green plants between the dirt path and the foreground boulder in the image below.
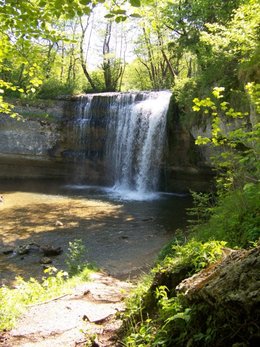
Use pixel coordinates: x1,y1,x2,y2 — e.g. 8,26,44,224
123,240,225,347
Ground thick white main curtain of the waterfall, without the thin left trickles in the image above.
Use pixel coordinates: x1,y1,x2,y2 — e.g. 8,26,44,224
107,92,171,200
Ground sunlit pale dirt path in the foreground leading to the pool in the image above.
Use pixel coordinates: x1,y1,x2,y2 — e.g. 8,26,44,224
0,273,133,347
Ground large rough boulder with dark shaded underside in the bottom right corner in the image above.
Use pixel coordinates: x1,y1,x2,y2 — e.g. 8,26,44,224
176,247,260,347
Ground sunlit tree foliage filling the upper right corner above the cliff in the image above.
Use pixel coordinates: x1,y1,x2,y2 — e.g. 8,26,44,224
165,0,260,126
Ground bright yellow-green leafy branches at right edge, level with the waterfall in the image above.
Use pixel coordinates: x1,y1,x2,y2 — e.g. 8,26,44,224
193,87,260,194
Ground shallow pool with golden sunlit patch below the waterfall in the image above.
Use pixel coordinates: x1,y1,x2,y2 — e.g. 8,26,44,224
0,180,191,284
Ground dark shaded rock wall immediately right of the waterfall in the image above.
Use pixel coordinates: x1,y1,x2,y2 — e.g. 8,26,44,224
165,97,214,192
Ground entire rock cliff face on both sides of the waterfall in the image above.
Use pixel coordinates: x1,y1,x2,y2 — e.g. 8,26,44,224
0,97,212,191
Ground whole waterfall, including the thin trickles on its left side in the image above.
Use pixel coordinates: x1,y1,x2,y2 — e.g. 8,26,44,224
70,91,171,199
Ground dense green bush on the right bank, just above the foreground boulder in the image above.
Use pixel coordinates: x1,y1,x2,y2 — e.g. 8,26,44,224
193,183,260,247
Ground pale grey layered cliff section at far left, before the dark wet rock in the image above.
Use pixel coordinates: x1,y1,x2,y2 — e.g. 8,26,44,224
0,101,71,178
